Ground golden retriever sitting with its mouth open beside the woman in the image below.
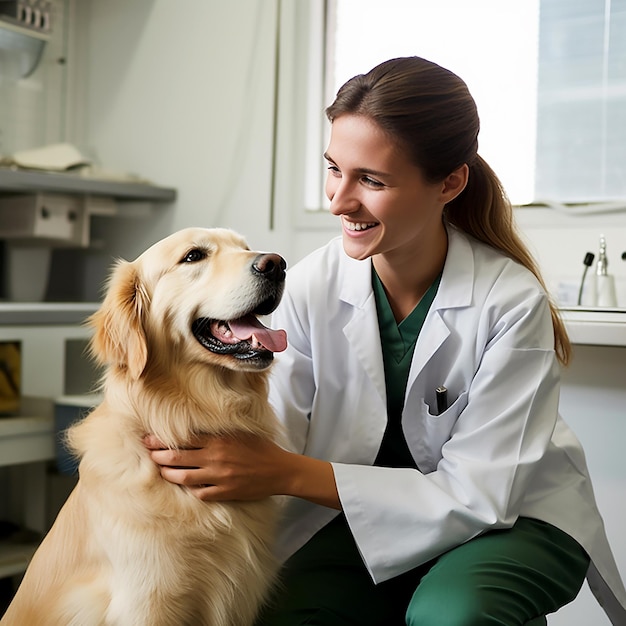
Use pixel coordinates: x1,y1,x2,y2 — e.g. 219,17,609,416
1,228,286,626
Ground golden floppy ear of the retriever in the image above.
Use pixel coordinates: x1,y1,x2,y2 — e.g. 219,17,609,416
87,261,149,380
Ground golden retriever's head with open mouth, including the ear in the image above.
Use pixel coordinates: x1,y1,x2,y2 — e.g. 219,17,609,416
88,228,287,379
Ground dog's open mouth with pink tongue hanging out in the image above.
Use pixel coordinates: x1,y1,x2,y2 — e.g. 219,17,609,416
191,314,287,360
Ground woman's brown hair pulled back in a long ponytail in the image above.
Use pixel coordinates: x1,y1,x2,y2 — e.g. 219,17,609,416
326,57,571,365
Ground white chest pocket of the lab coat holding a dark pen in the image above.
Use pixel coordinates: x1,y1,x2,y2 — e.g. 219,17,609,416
415,391,467,474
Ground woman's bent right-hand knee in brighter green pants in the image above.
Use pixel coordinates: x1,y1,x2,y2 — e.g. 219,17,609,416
406,518,589,626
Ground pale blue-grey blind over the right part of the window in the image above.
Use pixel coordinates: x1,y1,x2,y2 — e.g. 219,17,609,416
535,0,626,202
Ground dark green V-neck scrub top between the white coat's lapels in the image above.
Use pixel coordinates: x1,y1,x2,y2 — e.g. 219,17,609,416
372,266,441,468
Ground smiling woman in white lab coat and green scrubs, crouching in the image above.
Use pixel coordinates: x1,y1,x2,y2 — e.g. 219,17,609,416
147,58,626,626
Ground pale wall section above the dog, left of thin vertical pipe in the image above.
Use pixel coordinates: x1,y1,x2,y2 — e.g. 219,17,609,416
77,0,308,266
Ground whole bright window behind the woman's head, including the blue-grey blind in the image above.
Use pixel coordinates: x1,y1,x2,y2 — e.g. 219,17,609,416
298,0,626,210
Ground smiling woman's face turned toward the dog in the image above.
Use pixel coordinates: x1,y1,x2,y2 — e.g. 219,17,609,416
324,114,450,260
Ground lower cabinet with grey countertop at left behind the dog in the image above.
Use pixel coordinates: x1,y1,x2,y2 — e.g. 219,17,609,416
0,303,98,578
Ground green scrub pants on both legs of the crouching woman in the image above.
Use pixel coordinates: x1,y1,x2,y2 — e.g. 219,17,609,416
256,515,589,626
